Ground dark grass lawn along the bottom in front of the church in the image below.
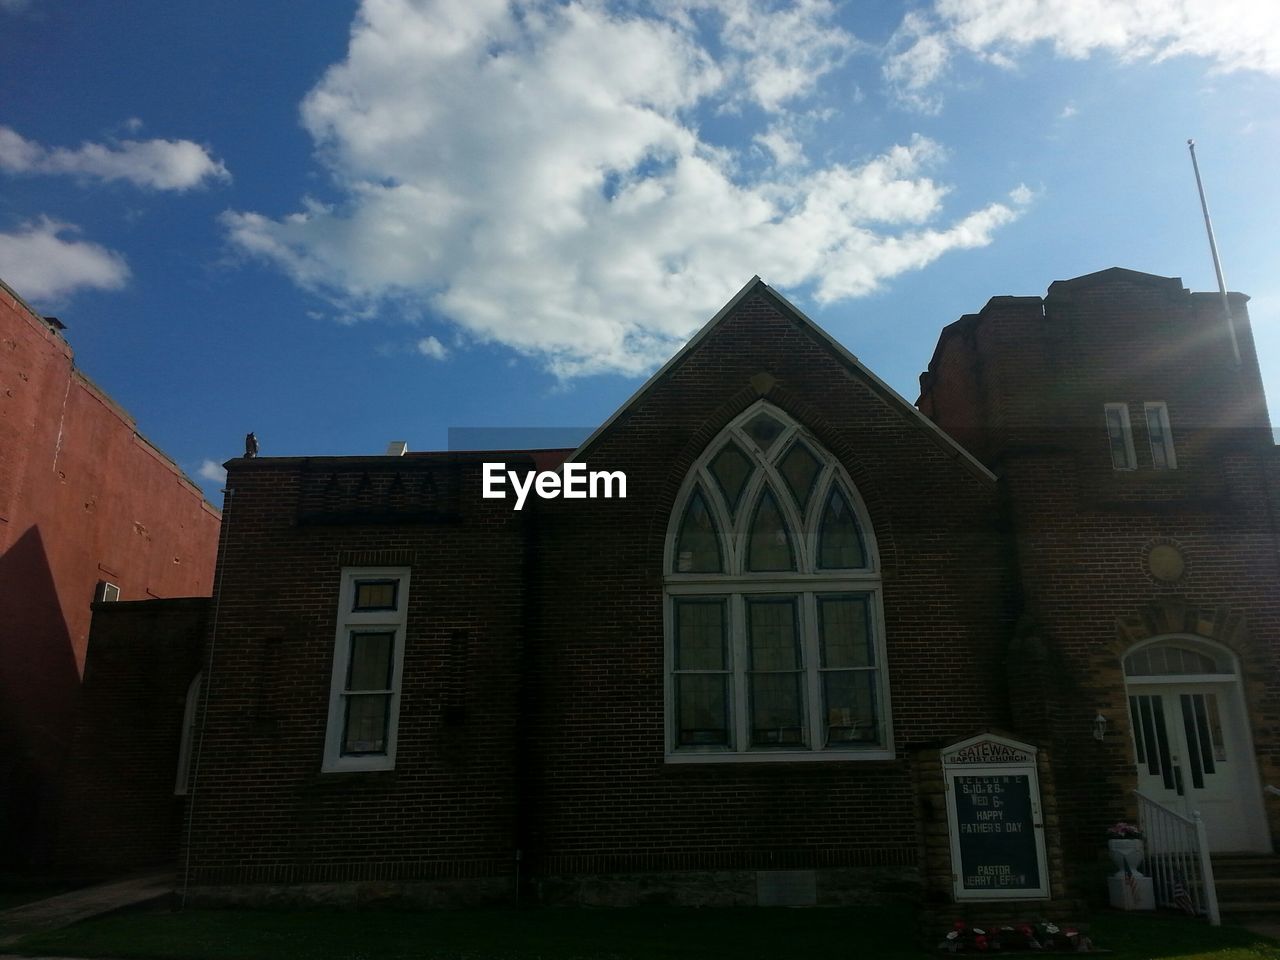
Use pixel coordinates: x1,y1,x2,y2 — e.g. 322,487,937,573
9,908,1280,960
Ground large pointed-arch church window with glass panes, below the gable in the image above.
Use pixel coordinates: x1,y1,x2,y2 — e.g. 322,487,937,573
666,401,893,762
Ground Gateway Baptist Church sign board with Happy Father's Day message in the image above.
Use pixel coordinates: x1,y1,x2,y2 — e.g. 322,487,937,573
942,733,1048,900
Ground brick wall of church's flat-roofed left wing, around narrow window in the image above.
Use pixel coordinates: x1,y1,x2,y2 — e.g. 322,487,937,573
181,454,529,884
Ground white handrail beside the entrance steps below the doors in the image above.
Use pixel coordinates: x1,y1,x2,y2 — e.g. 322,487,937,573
1133,790,1222,927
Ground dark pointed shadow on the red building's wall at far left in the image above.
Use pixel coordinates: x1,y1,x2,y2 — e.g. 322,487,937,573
0,526,81,867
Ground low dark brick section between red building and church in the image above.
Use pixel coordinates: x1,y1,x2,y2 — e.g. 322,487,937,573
56,596,209,874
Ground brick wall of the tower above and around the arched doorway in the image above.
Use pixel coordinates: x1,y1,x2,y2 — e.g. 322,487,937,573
922,270,1280,880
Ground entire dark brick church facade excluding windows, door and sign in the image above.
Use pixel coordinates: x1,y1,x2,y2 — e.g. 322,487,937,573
154,271,1280,902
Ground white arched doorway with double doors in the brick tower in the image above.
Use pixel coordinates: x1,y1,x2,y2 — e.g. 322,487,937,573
1124,635,1271,852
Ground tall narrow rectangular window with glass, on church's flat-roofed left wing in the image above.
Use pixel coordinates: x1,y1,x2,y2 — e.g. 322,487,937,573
321,567,408,773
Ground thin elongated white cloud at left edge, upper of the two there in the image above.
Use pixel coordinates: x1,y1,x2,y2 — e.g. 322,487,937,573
0,127,230,191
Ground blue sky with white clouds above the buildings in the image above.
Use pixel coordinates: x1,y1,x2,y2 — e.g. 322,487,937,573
0,0,1280,504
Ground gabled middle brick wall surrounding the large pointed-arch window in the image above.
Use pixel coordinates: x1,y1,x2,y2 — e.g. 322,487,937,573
519,292,1007,873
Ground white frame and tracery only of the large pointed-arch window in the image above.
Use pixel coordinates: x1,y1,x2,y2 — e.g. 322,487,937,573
663,401,895,763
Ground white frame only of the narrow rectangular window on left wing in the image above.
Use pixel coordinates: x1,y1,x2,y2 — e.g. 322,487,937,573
321,567,410,773
